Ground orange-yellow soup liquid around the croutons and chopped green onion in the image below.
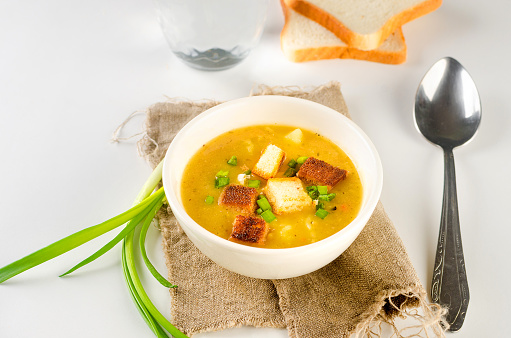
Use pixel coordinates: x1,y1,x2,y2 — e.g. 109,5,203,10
181,125,362,248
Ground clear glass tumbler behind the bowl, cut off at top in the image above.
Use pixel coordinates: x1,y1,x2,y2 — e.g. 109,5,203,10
155,0,269,70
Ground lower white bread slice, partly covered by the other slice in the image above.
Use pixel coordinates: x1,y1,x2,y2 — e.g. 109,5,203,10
280,1,406,64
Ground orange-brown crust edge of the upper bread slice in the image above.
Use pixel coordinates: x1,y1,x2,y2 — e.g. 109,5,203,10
282,0,442,50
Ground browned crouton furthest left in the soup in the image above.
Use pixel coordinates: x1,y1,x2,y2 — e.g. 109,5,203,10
218,184,259,214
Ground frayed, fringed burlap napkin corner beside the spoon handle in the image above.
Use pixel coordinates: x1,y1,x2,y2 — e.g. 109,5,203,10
350,287,449,338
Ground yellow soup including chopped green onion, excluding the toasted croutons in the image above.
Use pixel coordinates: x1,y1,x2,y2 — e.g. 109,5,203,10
181,125,362,248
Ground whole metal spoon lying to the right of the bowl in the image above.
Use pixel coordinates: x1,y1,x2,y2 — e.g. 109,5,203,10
414,57,481,331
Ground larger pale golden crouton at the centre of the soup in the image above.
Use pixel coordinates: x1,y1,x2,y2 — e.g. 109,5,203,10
263,177,313,215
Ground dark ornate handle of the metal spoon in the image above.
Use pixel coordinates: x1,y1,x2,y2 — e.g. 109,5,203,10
431,148,469,331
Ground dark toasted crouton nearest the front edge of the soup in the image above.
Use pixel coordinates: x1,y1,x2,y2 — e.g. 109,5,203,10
229,215,269,244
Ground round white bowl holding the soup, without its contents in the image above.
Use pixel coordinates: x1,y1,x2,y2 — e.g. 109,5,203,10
163,96,383,279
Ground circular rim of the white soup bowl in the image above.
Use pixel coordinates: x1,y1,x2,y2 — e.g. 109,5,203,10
162,95,383,256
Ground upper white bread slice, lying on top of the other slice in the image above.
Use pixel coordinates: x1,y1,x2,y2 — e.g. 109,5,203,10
283,0,442,50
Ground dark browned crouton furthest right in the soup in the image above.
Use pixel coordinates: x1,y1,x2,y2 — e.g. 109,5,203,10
296,157,346,190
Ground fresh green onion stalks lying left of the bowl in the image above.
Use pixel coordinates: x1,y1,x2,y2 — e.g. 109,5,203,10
0,162,187,338
